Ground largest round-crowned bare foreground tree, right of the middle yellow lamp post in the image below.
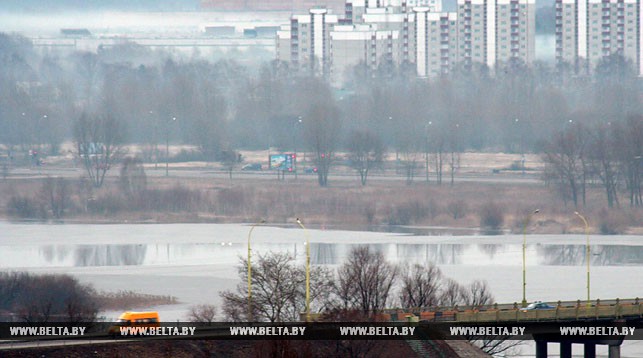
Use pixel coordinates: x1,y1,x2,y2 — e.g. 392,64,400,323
335,246,398,313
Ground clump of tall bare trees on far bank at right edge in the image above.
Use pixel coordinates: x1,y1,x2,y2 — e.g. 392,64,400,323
543,115,643,208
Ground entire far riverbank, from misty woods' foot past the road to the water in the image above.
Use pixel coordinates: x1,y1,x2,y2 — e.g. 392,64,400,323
0,146,643,235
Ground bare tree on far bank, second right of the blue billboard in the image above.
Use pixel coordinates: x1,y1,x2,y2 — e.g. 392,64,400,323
348,130,384,185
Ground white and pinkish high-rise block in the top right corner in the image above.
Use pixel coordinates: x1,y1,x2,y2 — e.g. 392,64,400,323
556,0,643,75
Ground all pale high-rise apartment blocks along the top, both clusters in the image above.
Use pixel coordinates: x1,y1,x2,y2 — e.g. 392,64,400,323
276,0,643,83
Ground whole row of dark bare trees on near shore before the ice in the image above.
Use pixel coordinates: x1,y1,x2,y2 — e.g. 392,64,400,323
221,246,518,356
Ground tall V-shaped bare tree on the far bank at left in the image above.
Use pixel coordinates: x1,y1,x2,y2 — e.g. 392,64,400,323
74,113,124,187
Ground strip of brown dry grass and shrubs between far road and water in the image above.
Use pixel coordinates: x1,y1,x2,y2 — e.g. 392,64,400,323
0,176,643,235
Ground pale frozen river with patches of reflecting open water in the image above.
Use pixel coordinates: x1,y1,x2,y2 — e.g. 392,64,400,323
0,222,643,357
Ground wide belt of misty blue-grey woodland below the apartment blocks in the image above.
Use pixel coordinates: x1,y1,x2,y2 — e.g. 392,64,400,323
0,34,642,192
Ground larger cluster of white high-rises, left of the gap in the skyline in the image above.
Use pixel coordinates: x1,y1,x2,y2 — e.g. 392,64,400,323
276,0,540,82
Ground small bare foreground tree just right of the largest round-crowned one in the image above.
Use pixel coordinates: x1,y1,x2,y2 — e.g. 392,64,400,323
400,263,442,308
